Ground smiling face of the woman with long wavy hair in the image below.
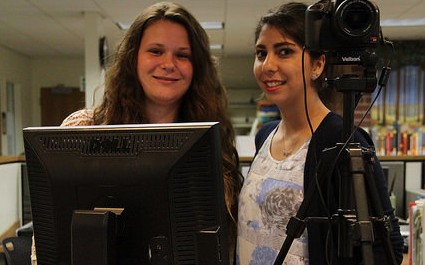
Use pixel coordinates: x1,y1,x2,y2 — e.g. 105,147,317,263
137,20,193,113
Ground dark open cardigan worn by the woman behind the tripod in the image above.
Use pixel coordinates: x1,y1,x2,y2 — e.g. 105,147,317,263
255,112,403,265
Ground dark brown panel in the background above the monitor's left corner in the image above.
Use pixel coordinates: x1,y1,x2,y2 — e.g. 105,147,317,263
41,86,85,126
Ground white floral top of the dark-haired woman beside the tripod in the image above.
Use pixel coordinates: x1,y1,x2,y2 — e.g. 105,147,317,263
236,129,310,265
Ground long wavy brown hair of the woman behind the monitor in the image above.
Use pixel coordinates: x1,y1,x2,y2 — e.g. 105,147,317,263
90,2,242,241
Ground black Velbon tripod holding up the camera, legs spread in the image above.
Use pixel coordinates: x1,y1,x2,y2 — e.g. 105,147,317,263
274,69,396,265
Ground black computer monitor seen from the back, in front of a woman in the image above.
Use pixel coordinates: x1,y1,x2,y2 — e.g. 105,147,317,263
23,122,229,265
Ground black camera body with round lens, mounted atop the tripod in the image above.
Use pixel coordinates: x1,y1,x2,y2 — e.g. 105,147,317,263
305,0,380,52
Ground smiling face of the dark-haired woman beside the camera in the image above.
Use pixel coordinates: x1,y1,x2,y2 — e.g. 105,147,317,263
253,24,321,107
